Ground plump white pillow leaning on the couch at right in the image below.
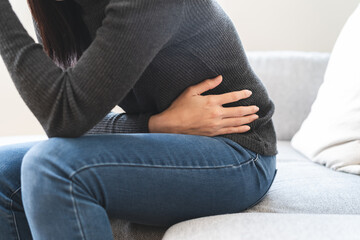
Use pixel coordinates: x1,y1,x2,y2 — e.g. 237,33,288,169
291,5,360,175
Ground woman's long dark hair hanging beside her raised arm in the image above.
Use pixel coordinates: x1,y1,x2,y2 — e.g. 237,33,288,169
27,0,91,69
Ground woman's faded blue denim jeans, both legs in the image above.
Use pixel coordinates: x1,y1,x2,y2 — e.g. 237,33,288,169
0,133,277,240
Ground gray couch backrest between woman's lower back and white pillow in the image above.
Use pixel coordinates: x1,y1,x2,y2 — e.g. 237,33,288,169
247,52,330,140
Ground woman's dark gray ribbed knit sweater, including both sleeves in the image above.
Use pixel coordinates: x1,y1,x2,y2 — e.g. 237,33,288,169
0,0,278,155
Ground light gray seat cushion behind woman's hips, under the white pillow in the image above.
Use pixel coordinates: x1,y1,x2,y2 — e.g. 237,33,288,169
247,141,360,214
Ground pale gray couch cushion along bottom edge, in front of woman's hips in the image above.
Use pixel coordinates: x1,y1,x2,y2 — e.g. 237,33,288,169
163,213,360,240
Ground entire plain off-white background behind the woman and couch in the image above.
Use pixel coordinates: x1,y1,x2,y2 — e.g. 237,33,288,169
0,0,359,136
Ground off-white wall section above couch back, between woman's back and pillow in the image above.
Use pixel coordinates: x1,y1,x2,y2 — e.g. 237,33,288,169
218,0,360,52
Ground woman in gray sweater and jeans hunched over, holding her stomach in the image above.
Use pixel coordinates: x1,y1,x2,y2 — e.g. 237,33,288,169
0,0,277,239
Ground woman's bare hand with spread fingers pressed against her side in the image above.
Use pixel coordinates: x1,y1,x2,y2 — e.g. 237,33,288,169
149,75,259,136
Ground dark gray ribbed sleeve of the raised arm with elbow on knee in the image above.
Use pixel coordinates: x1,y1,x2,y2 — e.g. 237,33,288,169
0,0,183,137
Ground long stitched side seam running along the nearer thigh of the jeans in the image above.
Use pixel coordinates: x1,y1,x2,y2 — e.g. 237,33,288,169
68,157,257,179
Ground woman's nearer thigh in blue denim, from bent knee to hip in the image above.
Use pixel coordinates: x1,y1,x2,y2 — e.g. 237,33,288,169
22,133,273,226
